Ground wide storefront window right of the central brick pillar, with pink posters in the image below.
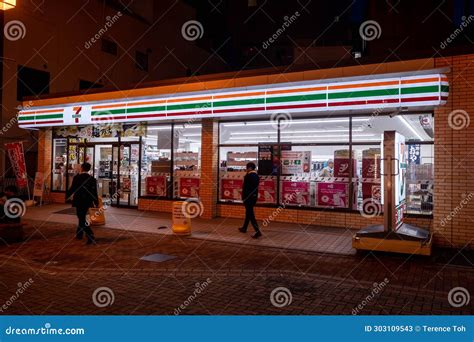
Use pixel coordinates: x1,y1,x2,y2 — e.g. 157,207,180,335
219,113,434,214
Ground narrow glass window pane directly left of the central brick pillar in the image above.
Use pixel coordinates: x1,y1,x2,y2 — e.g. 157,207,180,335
173,123,201,198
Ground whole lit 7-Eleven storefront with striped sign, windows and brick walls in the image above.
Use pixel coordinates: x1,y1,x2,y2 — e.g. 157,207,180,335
19,56,474,247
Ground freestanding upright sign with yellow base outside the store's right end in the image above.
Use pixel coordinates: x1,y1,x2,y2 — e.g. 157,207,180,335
352,131,432,255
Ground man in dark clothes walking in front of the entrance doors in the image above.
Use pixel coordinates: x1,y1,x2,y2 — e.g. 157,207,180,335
69,163,99,245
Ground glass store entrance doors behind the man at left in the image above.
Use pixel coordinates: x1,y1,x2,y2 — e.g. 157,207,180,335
68,142,140,207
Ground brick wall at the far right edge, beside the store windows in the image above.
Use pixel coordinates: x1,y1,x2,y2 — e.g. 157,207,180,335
433,55,474,249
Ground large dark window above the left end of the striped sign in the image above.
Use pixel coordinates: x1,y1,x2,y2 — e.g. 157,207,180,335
17,66,50,101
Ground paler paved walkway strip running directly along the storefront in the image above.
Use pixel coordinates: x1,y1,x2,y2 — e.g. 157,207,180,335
24,204,356,255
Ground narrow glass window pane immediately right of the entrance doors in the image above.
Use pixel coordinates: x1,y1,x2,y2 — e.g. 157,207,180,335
141,125,172,198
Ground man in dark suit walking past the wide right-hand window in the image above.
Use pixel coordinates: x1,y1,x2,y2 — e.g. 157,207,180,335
239,163,262,239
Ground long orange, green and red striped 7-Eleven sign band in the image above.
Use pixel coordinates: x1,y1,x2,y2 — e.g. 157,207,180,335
19,74,449,127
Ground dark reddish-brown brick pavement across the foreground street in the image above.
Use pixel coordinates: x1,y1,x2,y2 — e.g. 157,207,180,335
0,216,474,315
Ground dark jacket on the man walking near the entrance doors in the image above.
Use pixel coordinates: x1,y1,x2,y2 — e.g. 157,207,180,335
69,173,99,208
